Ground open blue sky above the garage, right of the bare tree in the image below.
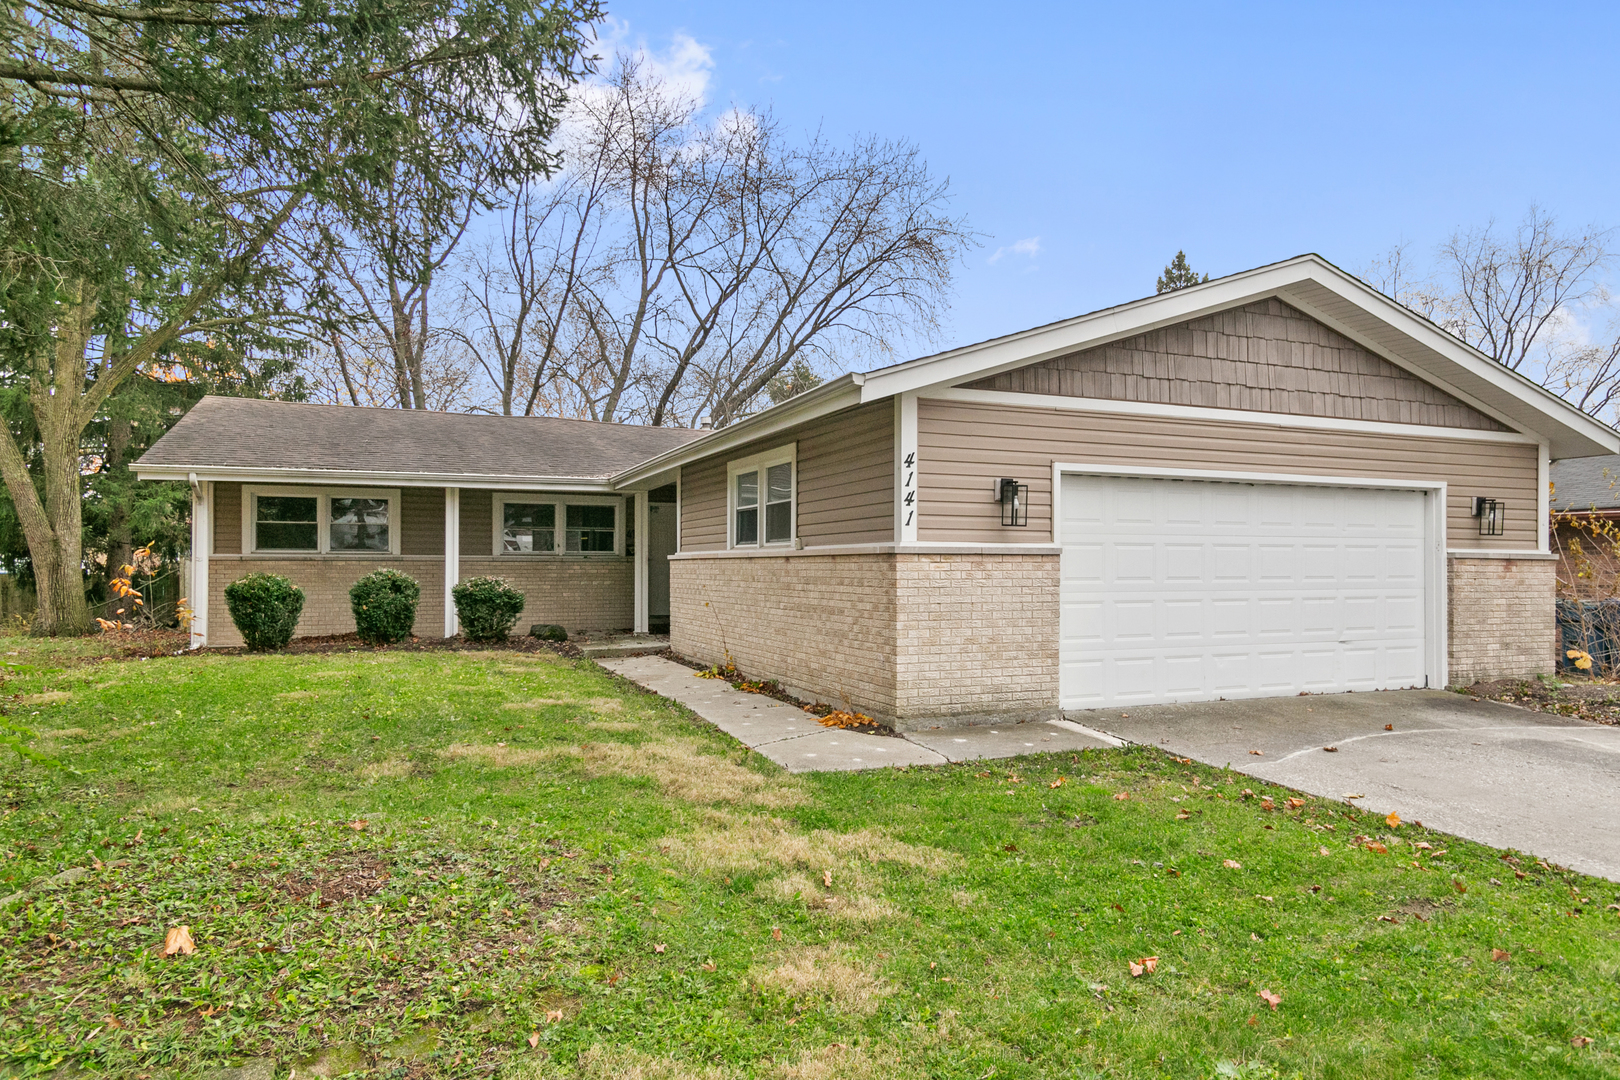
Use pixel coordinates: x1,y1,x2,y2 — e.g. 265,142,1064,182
589,0,1620,356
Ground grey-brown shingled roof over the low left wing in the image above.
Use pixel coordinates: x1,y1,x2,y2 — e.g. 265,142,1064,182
134,397,701,486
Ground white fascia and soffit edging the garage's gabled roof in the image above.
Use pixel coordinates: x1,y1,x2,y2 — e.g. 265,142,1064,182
614,254,1620,486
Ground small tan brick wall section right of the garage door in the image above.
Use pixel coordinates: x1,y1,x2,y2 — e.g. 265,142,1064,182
1447,557,1558,687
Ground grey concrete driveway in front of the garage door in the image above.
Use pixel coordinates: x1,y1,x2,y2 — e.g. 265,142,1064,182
1064,690,1620,881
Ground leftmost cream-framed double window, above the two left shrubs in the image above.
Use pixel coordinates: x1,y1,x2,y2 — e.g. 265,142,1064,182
241,487,400,555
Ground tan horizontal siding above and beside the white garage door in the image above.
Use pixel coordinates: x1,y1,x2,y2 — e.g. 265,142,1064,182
917,400,1539,549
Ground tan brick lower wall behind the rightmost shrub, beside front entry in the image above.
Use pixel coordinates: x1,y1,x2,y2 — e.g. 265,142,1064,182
462,557,635,633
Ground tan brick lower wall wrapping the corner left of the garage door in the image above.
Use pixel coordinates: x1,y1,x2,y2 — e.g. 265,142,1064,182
669,554,1058,729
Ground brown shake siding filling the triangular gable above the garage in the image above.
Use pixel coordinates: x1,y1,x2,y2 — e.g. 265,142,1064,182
964,300,1507,431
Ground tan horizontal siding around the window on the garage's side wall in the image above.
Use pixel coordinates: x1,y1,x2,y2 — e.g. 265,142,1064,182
680,402,894,551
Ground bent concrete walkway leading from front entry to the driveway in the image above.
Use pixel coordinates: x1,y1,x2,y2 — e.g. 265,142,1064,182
598,656,1119,772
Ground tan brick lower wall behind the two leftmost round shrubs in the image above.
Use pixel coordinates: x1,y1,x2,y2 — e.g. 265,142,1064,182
207,555,444,646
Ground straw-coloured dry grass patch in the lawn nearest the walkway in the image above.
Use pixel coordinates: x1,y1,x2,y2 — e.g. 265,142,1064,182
441,738,805,808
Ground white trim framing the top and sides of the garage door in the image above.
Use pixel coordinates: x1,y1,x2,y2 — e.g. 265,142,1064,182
1051,461,1450,690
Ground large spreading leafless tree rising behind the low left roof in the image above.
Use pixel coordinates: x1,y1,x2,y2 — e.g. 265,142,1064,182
462,57,972,424
